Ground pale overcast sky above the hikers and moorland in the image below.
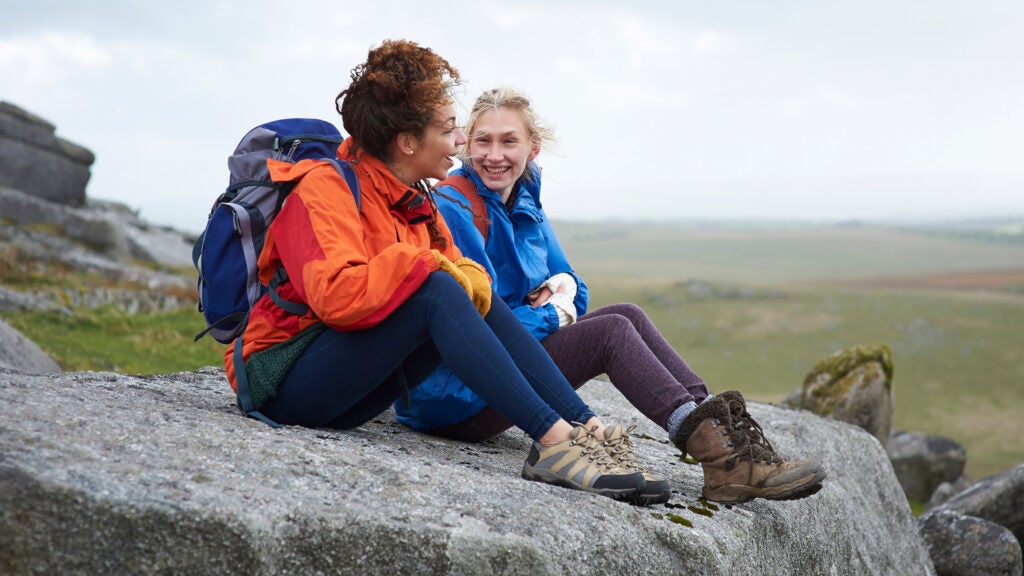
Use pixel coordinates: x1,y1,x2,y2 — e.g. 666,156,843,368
0,0,1024,232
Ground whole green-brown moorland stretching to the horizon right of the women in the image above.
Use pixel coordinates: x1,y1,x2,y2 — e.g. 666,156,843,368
557,219,1024,479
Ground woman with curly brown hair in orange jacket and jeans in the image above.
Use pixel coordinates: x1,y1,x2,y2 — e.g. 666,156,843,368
224,41,646,499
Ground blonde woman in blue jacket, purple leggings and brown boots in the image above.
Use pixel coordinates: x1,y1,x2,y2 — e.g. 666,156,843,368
395,88,824,502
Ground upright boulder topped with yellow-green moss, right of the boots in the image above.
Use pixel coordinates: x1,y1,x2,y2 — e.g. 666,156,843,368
784,344,893,446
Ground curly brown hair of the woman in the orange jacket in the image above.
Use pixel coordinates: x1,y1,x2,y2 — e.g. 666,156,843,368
334,40,461,160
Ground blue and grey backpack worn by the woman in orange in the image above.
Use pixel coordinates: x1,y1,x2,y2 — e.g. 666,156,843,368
193,118,359,420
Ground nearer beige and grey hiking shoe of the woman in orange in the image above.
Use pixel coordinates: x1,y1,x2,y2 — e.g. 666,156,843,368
522,423,644,500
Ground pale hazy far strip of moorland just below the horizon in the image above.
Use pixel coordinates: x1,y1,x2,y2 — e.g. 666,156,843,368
556,222,1024,285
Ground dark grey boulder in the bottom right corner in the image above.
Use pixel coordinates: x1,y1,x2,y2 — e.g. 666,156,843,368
921,510,1024,576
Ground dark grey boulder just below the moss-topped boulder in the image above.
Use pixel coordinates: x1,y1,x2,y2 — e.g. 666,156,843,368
886,431,967,502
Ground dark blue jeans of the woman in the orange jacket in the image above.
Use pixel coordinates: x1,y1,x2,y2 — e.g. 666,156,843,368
262,273,594,440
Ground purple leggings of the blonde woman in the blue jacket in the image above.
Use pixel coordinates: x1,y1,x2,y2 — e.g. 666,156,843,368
430,303,709,442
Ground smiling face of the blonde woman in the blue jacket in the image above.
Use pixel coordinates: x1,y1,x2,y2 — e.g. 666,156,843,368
468,107,541,200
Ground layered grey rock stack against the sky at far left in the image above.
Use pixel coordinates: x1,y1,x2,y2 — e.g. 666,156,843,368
0,101,95,206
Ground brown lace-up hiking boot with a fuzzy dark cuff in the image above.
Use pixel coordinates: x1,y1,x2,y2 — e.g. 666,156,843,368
672,390,825,504
